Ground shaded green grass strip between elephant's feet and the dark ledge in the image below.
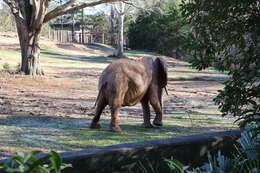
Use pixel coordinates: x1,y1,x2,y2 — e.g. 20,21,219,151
0,113,234,154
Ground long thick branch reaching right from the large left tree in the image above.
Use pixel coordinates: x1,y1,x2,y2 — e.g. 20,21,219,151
44,0,126,23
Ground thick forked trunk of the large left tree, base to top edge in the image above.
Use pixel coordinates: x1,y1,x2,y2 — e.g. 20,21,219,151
12,0,48,76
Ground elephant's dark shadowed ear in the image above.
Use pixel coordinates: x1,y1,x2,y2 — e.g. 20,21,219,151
155,58,168,88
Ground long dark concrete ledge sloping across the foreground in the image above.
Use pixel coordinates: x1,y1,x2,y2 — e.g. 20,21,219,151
61,130,241,173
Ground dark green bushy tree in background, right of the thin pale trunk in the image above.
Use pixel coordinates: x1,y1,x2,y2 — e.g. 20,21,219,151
128,3,186,56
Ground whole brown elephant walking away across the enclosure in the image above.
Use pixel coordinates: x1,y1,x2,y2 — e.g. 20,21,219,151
90,57,167,132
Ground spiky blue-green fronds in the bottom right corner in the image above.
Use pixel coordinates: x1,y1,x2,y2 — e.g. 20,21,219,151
166,127,260,173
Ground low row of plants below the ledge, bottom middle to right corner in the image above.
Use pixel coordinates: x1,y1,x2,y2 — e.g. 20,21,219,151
133,126,260,173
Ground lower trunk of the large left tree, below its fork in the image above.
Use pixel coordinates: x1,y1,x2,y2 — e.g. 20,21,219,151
17,22,44,76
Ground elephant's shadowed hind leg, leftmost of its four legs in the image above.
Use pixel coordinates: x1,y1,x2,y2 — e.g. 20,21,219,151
90,98,107,129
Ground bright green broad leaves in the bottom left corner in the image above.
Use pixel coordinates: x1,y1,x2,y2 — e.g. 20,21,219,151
0,151,71,173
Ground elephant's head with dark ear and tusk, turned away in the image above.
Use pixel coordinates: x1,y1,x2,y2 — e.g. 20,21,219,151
153,58,168,107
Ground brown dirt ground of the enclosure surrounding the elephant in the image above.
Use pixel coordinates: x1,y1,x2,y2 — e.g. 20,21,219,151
0,34,236,158
